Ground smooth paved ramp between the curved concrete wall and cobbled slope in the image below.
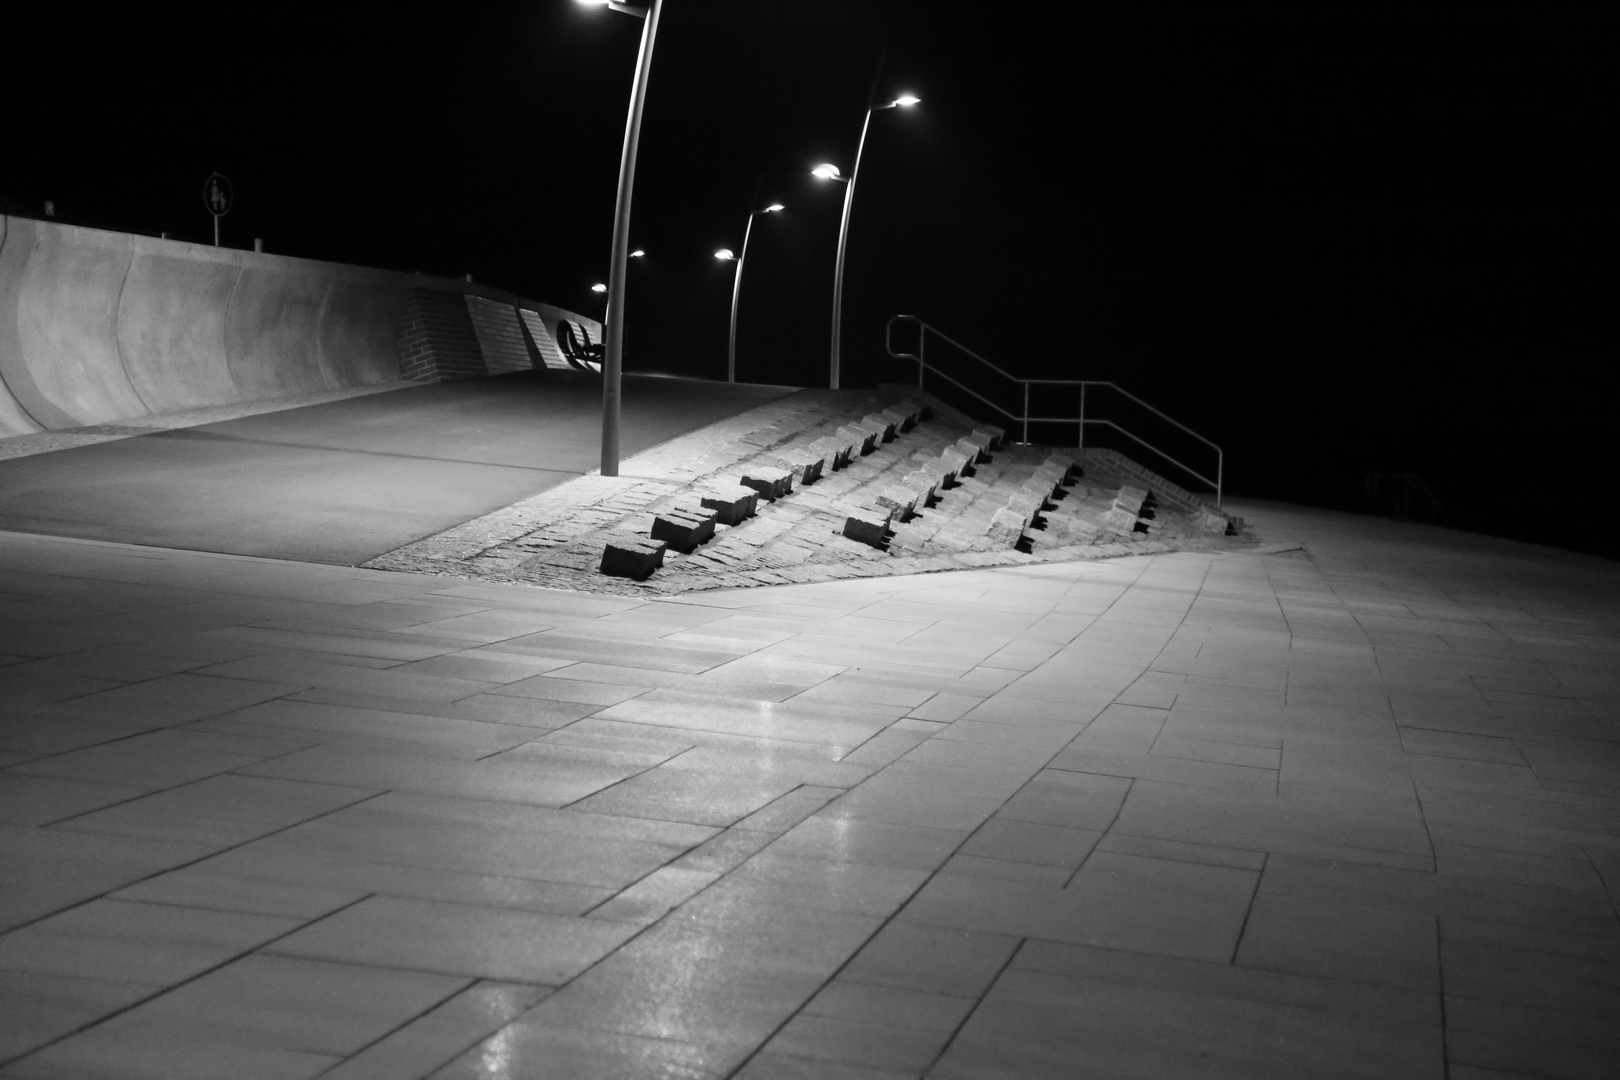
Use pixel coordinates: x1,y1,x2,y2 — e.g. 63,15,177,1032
0,371,791,565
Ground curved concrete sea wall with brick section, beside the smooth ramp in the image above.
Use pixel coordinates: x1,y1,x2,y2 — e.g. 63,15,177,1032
0,215,601,437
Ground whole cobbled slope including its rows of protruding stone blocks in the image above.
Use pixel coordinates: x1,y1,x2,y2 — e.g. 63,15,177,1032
368,387,1243,593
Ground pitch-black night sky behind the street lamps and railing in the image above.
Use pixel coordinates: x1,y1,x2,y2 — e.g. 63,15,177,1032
0,0,1620,555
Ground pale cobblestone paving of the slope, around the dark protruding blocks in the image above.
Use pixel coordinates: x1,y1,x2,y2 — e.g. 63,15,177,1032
366,383,1252,596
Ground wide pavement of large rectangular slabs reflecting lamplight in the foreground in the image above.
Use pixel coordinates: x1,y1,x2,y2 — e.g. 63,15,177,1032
0,505,1620,1080
